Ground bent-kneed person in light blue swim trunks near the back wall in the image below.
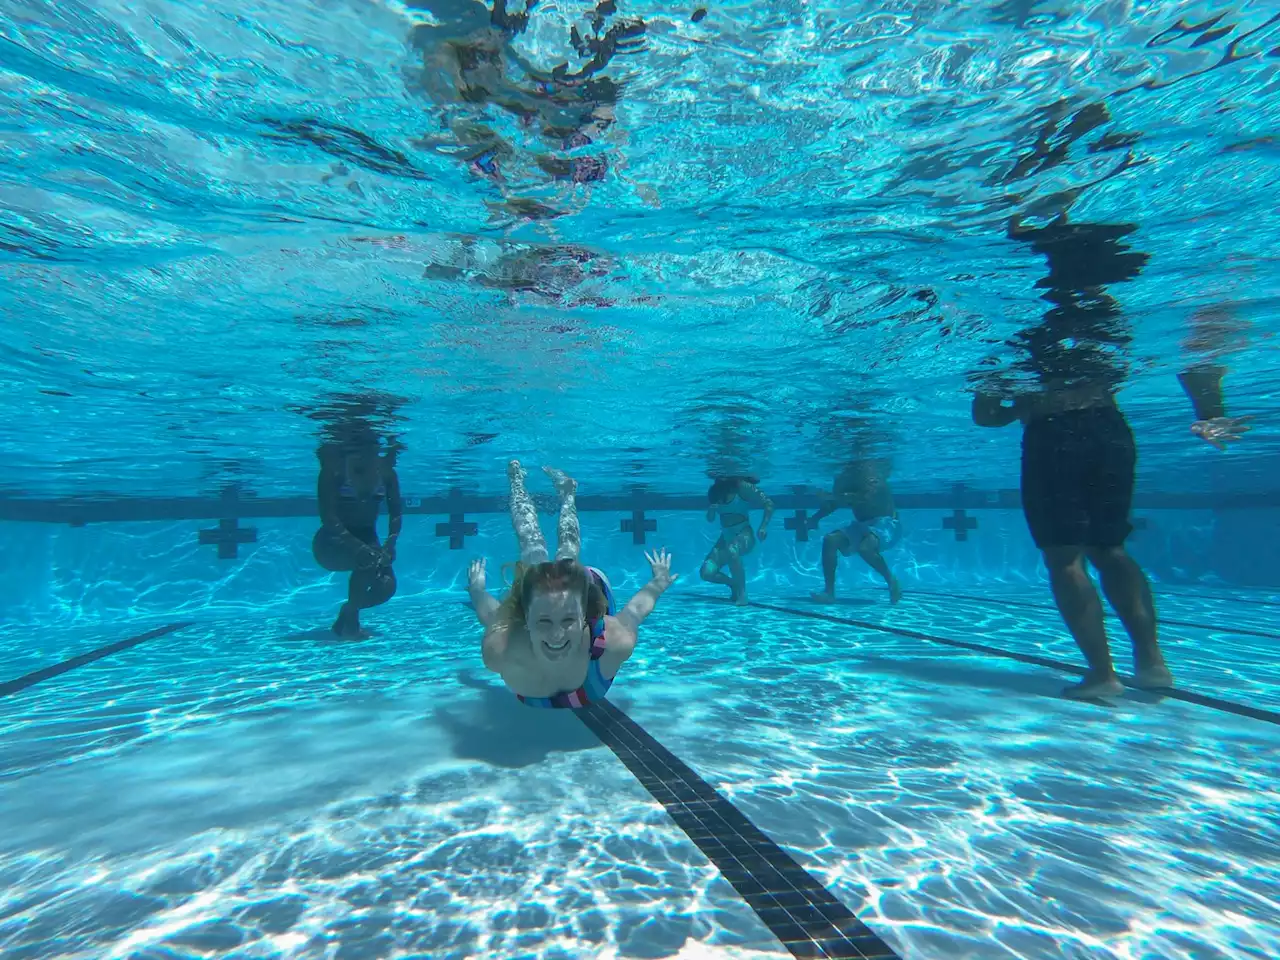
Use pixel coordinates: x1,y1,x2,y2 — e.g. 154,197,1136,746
808,460,902,603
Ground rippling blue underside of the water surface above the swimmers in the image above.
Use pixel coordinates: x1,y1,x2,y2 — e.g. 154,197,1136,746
0,0,1280,494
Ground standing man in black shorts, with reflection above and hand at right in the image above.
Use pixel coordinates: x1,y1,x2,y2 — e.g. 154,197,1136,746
973,212,1248,700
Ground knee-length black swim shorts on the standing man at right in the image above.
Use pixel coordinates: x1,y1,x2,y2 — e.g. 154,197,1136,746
1023,406,1137,549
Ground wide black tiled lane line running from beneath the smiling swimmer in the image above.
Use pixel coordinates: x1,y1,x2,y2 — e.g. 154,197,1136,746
575,700,900,960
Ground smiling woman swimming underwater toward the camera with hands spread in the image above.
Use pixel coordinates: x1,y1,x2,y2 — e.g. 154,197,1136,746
468,460,676,709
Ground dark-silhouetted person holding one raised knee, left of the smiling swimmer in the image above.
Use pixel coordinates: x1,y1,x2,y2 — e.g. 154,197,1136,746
311,440,403,640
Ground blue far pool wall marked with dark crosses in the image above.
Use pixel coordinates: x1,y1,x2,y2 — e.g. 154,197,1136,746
0,492,1280,625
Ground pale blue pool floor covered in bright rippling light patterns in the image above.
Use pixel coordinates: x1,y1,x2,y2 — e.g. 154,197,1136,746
0,588,1280,960
